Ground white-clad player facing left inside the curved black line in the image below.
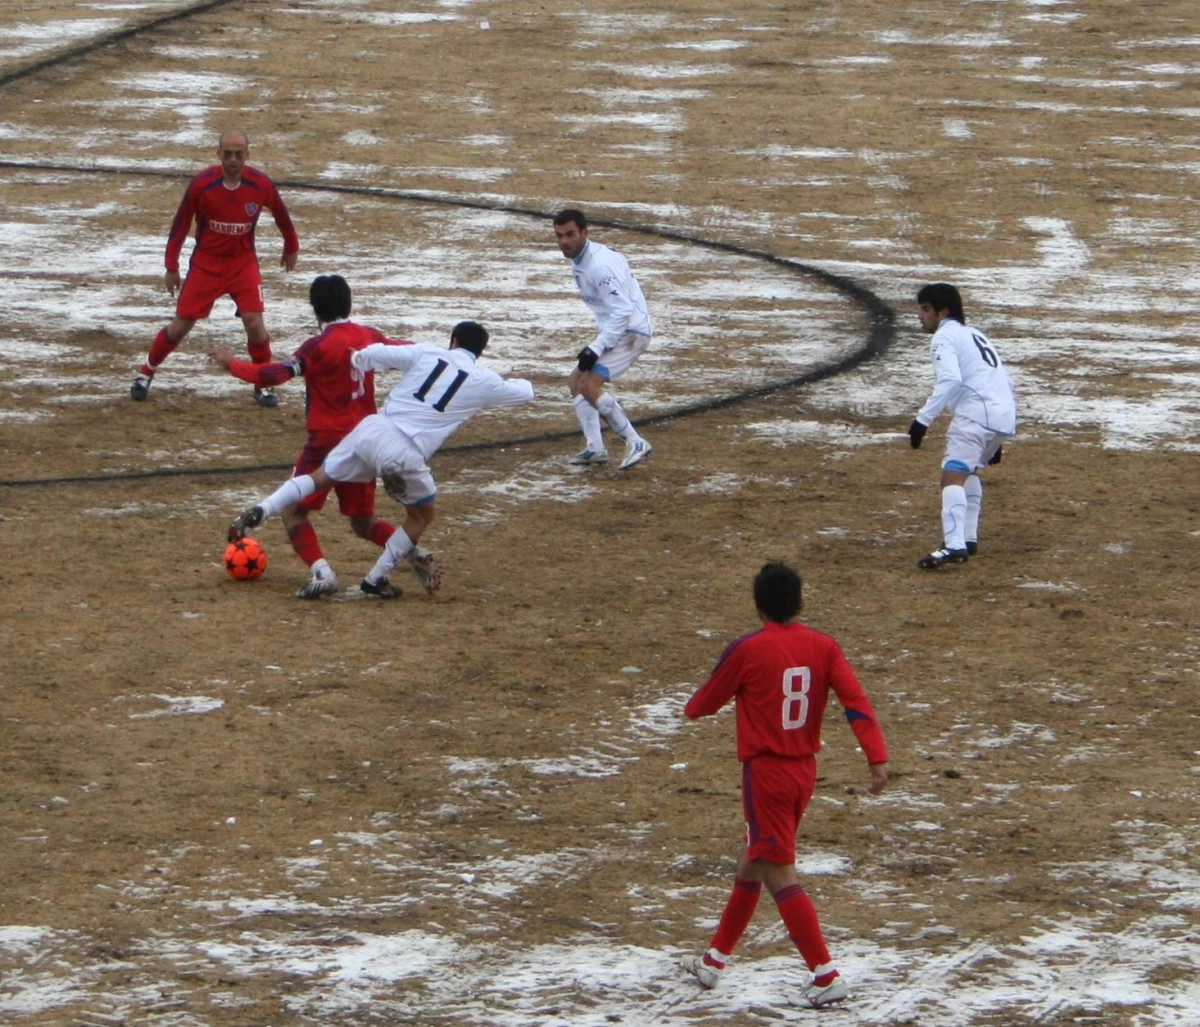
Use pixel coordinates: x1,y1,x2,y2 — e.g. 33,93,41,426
554,208,654,470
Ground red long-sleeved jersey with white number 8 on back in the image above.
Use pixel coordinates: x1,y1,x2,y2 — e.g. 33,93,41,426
684,620,888,763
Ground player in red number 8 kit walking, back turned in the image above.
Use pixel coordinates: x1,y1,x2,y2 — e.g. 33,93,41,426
684,563,888,1007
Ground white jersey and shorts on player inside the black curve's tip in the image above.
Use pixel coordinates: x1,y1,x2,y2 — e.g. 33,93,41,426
571,240,654,379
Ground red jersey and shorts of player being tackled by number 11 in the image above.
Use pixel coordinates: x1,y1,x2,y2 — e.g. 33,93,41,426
229,320,409,518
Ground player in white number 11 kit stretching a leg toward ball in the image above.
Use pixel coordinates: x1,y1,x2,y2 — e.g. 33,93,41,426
229,322,533,599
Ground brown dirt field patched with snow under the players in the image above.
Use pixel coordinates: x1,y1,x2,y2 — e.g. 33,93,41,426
0,0,1200,1027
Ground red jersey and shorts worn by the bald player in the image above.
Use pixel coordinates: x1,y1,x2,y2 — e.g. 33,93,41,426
167,164,300,320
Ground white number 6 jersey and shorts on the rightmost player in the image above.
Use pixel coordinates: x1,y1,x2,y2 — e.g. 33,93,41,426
917,318,1016,474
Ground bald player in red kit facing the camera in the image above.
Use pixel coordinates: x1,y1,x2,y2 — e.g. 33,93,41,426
130,131,300,407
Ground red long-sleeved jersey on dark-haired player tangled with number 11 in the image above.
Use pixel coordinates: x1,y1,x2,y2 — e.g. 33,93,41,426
229,320,412,442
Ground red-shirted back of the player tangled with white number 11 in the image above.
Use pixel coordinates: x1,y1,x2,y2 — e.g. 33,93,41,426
292,320,389,436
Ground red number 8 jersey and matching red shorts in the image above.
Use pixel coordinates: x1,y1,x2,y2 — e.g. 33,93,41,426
684,620,888,864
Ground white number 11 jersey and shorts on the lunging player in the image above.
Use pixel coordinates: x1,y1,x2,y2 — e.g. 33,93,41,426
324,343,533,505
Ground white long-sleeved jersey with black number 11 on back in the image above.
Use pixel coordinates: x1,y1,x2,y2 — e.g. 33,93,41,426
350,342,533,461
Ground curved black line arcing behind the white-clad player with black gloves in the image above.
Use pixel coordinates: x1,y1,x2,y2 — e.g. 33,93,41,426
0,167,895,487
